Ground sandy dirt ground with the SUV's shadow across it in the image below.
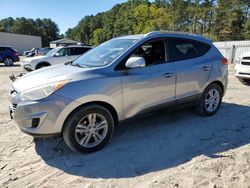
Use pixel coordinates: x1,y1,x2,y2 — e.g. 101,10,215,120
0,62,250,188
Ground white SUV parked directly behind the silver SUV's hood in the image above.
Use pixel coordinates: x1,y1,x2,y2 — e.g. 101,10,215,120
21,46,92,71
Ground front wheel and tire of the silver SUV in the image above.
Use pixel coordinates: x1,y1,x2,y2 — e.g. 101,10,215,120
62,105,114,153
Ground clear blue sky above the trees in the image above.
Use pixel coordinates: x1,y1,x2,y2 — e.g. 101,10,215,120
0,0,126,34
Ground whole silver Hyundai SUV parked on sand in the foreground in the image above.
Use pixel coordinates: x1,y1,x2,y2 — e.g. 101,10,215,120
10,32,228,152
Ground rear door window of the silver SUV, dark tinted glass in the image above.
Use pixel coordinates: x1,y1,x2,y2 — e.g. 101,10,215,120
169,38,210,61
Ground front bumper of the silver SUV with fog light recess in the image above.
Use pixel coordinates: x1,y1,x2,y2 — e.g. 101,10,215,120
9,94,71,137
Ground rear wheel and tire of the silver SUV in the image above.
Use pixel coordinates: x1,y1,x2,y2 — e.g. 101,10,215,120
195,84,222,116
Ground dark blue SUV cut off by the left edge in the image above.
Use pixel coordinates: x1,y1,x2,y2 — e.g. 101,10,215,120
0,46,19,66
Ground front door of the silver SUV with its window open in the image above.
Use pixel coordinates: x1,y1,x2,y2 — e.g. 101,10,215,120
119,40,175,118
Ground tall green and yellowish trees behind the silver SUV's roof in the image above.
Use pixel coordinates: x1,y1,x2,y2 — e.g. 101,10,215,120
65,0,250,45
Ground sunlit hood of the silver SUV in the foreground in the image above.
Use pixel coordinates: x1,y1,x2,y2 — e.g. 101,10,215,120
12,64,102,93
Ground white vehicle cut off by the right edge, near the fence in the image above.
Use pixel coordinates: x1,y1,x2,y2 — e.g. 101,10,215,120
234,52,250,84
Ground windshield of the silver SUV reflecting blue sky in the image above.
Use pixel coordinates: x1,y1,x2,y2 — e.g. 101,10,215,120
73,39,137,67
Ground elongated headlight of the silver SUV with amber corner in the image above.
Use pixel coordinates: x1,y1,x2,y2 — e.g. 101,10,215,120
20,80,68,101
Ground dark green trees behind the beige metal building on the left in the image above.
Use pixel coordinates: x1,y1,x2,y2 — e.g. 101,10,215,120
0,17,62,46
